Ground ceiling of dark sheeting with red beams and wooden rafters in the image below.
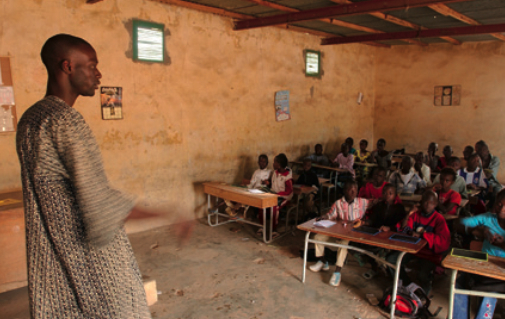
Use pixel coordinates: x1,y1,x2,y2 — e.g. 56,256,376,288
147,0,505,47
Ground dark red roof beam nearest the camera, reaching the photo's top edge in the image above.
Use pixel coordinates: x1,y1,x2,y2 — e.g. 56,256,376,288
235,0,467,30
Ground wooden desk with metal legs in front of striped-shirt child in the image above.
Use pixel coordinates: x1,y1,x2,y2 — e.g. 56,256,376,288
298,219,426,318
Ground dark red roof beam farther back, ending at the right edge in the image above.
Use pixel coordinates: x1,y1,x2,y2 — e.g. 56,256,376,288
321,24,505,45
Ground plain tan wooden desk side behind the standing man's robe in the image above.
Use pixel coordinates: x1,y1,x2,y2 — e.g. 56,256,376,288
0,190,28,293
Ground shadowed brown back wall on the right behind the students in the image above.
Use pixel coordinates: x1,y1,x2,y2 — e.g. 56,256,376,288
374,41,505,183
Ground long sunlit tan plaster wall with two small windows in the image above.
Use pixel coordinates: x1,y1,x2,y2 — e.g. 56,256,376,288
0,0,375,231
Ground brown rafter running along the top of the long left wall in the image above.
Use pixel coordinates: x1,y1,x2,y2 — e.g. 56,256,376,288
150,0,391,48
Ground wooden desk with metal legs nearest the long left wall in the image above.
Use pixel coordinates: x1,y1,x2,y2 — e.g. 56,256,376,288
203,182,287,243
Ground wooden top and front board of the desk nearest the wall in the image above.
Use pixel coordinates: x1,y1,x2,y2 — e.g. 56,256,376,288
203,182,278,208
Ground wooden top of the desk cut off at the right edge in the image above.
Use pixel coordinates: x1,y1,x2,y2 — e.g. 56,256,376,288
442,255,505,280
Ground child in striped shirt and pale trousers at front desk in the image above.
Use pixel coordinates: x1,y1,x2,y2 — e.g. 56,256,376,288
309,181,371,286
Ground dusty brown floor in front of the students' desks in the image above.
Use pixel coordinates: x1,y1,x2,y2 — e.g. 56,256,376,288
0,221,505,319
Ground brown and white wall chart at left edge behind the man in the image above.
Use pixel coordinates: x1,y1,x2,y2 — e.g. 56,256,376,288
0,57,17,133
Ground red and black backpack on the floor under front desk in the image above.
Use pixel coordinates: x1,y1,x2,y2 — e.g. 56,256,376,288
379,280,442,319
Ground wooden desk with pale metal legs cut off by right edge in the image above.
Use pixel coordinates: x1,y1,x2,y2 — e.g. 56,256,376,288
442,255,505,319
